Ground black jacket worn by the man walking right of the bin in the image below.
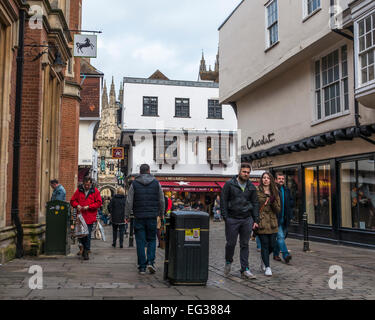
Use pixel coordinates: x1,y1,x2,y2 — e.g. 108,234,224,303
220,176,259,223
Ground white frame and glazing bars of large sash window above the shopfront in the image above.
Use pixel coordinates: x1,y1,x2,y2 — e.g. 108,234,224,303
312,42,350,125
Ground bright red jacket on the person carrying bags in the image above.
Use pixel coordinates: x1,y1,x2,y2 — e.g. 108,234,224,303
70,185,102,224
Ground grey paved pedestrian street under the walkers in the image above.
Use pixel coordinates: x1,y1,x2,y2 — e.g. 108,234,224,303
0,222,375,300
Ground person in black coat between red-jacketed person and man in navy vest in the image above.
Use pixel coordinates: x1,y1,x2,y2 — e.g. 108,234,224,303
108,187,126,248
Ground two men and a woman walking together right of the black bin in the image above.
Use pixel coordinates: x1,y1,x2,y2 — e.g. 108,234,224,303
220,163,293,279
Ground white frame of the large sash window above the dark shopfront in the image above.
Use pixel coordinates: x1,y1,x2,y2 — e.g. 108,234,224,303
312,42,350,125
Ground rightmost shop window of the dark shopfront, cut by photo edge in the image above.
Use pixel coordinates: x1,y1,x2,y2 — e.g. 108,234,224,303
340,159,375,230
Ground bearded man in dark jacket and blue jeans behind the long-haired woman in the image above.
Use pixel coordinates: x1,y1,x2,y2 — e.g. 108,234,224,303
273,172,294,263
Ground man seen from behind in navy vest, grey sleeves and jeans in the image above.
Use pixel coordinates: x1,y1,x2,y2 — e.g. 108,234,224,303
125,164,165,274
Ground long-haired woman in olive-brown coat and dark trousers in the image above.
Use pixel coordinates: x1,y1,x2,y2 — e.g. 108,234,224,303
257,172,280,276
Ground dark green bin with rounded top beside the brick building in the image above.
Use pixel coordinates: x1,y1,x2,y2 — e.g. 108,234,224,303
44,200,70,255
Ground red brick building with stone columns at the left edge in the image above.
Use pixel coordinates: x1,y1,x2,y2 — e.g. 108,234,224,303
0,0,82,263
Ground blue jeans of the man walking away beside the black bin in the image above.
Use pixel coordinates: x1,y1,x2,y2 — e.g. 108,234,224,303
134,218,157,270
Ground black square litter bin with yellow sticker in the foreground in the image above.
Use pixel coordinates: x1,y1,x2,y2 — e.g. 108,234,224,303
164,211,210,286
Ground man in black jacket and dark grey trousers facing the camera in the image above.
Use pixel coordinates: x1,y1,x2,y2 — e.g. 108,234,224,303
220,163,259,279
